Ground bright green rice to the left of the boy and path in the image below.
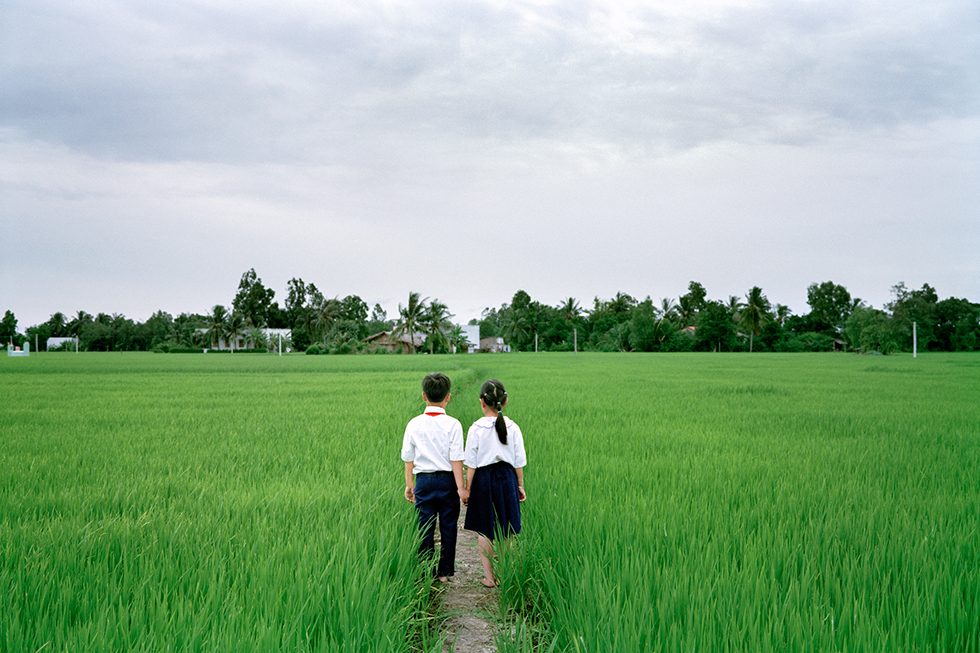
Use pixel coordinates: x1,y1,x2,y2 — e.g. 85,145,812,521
0,354,468,652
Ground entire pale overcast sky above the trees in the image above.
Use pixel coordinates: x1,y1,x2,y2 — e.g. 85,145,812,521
0,0,980,330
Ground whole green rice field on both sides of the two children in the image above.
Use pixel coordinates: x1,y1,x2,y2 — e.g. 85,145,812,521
0,354,980,651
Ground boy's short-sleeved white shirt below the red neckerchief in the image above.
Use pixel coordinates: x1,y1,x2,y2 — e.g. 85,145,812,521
402,406,463,474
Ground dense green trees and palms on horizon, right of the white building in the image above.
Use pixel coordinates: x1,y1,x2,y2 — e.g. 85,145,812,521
479,281,980,354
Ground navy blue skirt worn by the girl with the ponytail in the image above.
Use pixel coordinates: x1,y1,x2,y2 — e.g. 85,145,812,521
463,462,521,540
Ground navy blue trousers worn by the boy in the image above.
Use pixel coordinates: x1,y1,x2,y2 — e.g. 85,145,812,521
415,472,459,576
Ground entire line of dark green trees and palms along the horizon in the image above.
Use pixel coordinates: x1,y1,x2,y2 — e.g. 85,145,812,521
0,269,980,354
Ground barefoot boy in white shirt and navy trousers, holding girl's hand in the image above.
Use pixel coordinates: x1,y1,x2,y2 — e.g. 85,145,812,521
402,372,468,583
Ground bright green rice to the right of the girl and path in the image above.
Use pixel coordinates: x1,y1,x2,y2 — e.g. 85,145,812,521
493,355,980,651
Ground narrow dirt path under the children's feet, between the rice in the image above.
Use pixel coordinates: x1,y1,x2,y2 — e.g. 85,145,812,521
442,506,497,653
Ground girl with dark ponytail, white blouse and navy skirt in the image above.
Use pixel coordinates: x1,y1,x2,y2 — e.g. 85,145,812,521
463,379,527,587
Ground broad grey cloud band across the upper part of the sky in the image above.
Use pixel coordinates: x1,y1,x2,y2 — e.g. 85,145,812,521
0,3,980,164
